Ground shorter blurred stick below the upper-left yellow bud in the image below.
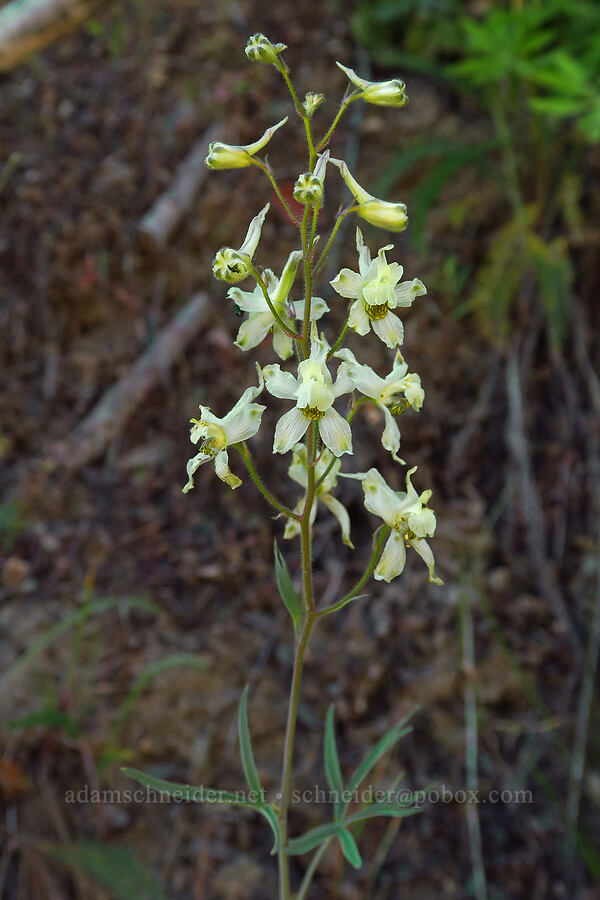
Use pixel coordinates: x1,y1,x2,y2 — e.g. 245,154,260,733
139,127,217,247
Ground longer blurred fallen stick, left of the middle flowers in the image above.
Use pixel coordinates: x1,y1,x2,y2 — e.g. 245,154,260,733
55,294,209,470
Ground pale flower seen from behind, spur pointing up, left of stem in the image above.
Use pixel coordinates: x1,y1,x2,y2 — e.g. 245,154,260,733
227,250,329,359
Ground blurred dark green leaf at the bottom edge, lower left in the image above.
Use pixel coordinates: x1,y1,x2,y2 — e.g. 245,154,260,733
46,841,166,900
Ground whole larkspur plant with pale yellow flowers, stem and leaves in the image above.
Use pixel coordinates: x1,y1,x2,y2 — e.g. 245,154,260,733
124,34,441,900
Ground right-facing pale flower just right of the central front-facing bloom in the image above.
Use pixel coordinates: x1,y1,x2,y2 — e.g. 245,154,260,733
334,348,425,463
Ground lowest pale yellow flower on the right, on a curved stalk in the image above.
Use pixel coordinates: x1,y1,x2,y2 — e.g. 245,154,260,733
344,467,443,584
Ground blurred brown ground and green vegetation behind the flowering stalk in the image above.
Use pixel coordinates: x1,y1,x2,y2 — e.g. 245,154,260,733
0,0,600,900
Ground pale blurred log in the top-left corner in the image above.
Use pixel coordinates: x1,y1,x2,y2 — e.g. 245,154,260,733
0,0,108,72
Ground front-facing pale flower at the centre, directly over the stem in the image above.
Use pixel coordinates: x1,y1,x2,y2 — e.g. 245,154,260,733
262,326,353,456
